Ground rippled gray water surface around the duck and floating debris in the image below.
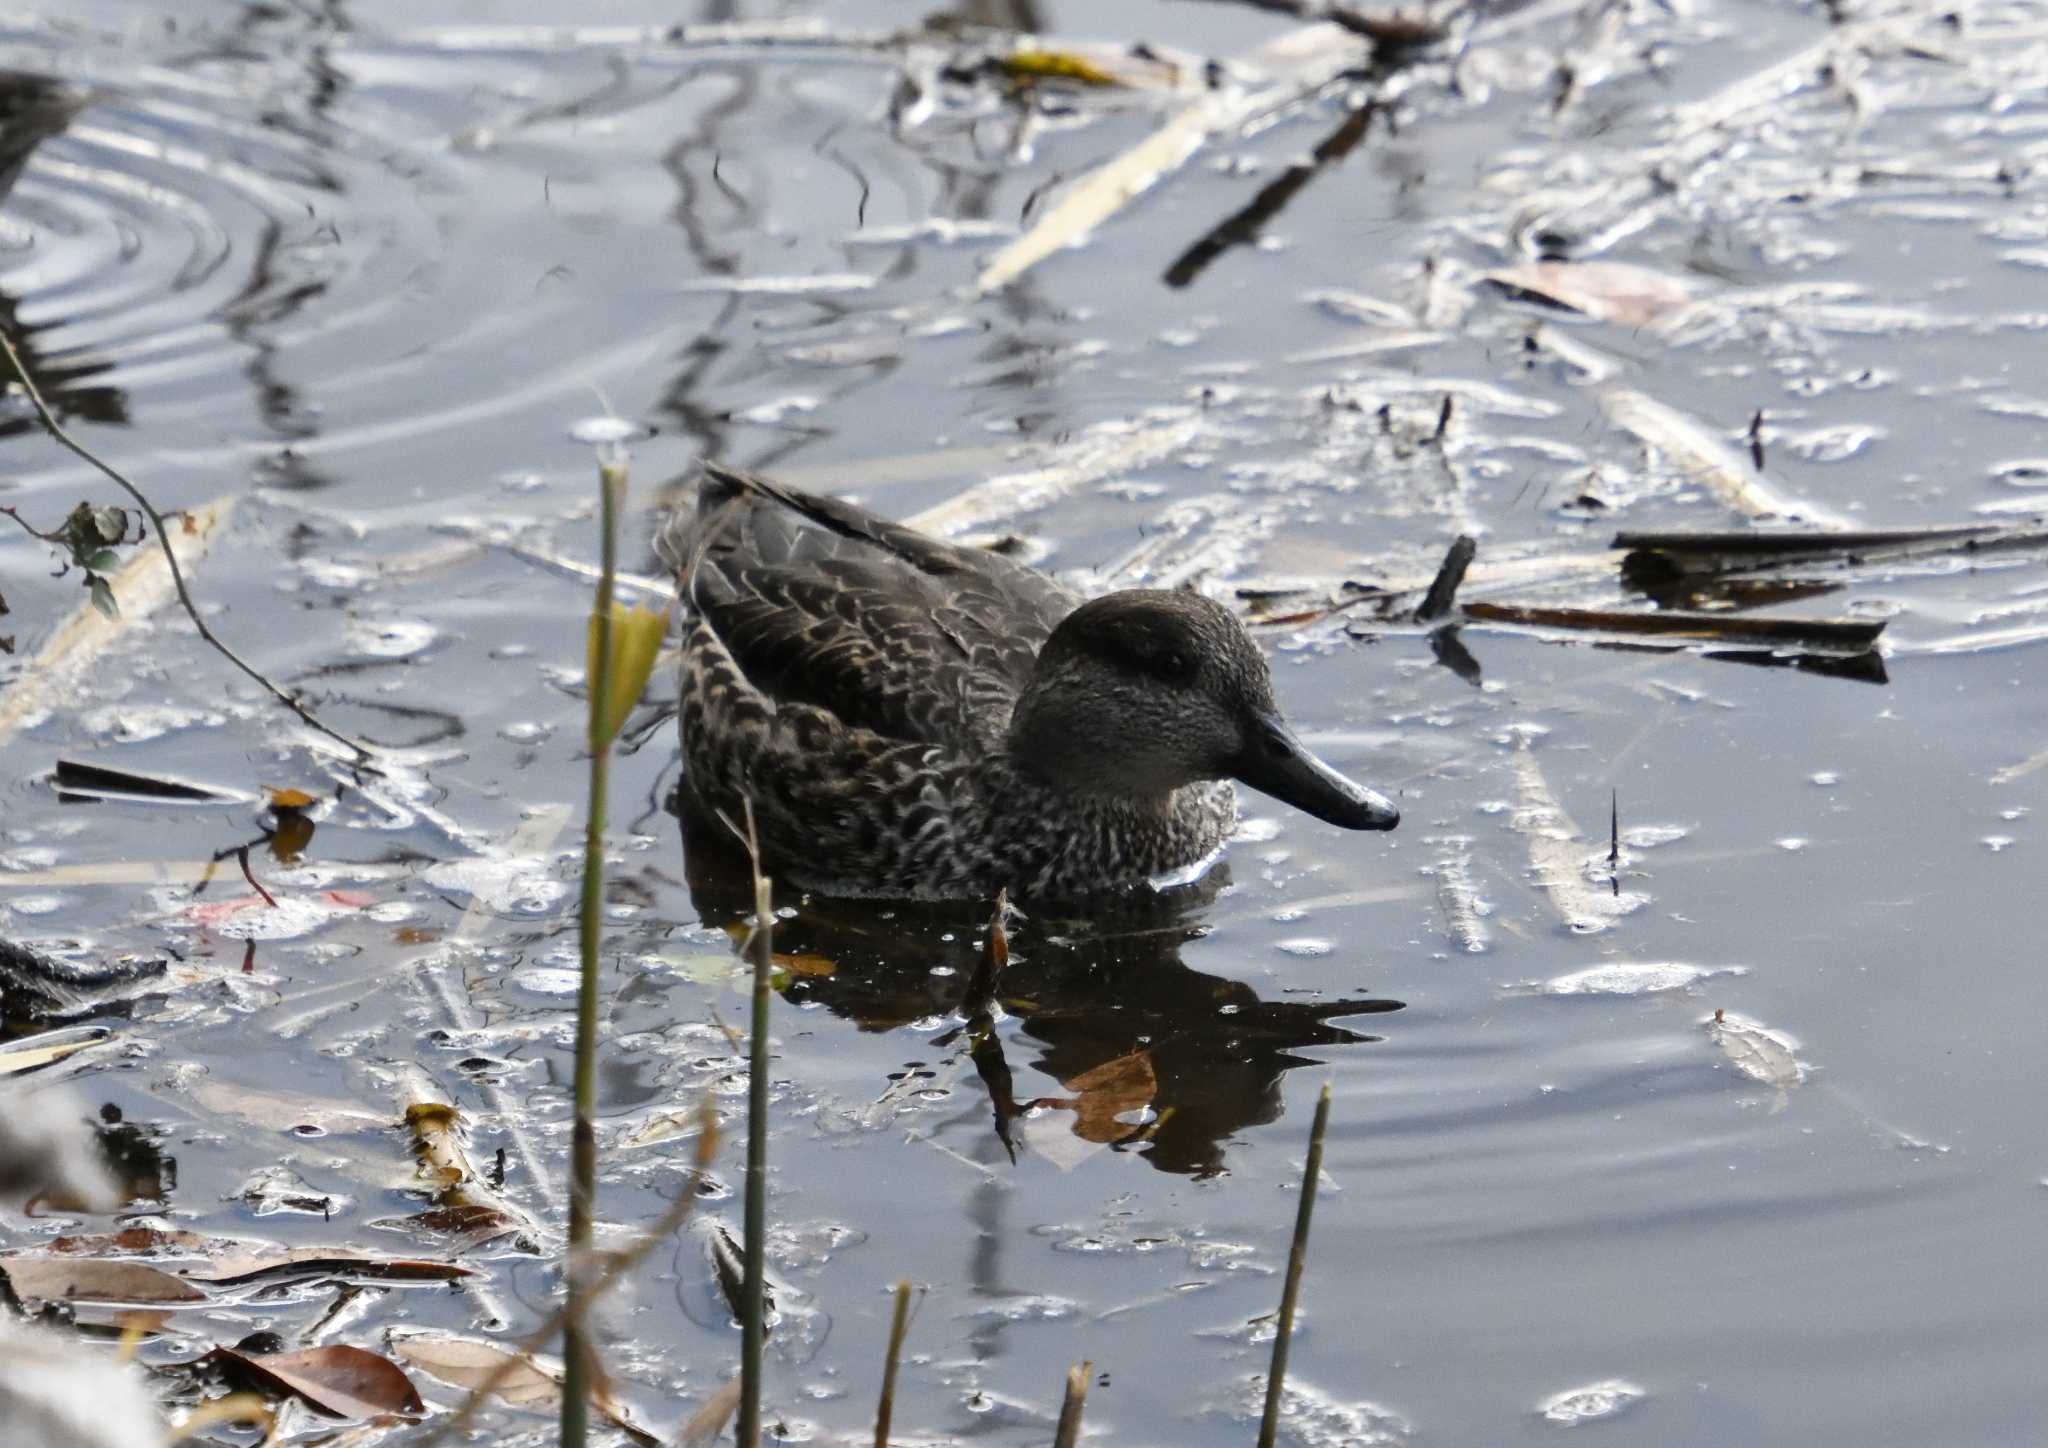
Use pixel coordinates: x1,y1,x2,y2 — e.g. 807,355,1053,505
0,2,2048,1446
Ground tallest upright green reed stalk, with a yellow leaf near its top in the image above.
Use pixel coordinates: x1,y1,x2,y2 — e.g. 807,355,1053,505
561,461,625,1448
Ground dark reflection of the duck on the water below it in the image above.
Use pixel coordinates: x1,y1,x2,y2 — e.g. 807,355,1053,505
682,819,1401,1176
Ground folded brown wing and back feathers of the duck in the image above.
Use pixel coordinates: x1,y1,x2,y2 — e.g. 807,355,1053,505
659,463,1077,746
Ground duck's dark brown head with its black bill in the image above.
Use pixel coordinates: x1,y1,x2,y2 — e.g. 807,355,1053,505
1010,588,1401,829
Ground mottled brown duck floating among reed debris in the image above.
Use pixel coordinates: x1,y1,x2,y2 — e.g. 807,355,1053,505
657,461,1401,901
